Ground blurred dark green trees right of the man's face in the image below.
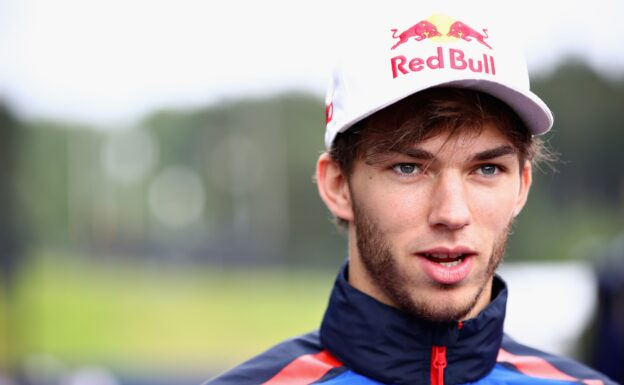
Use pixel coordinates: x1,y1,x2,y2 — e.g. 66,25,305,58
508,59,624,260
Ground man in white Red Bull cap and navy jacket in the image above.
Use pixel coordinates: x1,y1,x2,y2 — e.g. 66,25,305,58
208,8,614,385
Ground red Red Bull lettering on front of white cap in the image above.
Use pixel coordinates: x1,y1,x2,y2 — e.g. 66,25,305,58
390,47,496,78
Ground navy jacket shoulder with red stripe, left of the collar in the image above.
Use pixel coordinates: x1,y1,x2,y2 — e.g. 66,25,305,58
203,331,342,385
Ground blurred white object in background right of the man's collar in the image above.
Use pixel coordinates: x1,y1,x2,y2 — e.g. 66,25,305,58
499,262,597,355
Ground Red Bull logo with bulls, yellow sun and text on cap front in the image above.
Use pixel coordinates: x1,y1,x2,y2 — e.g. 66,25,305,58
390,15,496,78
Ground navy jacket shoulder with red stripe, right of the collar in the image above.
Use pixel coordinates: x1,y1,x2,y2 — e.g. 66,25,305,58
497,335,618,385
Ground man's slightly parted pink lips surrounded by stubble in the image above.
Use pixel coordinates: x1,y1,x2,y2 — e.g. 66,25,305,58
413,246,477,285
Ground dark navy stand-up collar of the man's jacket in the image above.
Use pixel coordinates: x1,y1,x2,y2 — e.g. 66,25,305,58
320,264,507,385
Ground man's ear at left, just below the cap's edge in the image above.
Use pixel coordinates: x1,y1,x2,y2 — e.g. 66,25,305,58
316,152,353,222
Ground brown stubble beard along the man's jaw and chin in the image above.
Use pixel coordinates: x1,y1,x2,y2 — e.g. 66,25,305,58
353,201,511,322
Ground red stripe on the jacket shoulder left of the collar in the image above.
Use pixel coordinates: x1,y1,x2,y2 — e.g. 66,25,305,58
262,350,342,385
